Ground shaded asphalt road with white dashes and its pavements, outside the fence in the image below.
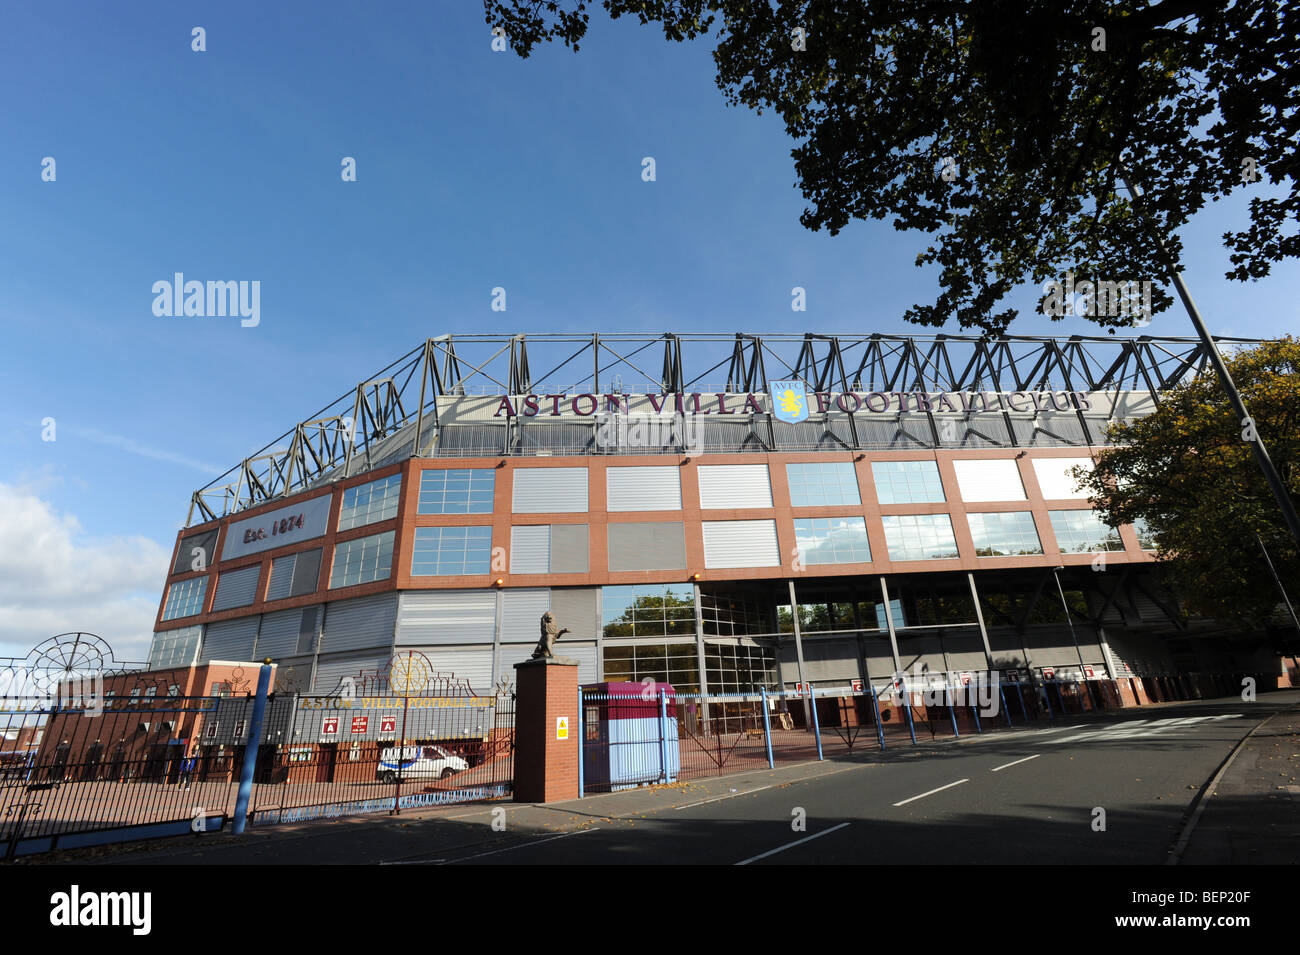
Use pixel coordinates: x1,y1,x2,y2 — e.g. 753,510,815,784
18,690,1300,865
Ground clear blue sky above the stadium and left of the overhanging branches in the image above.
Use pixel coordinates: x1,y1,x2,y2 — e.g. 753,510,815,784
0,0,1300,654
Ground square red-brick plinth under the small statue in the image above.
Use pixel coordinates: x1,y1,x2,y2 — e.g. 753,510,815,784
515,660,581,803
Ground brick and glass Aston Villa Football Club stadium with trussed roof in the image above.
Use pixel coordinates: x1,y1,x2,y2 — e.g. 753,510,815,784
150,334,1300,703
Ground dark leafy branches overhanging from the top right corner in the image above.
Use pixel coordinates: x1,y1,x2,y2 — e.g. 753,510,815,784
484,0,1300,334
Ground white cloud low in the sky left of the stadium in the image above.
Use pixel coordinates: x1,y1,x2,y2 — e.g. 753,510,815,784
0,483,170,661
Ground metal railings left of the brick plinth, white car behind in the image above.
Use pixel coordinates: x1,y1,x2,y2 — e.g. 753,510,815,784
0,694,515,860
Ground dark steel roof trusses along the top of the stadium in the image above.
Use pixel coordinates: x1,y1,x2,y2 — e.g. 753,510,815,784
186,333,1258,525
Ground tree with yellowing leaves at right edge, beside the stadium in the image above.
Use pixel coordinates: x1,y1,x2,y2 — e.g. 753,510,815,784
1083,338,1300,625
